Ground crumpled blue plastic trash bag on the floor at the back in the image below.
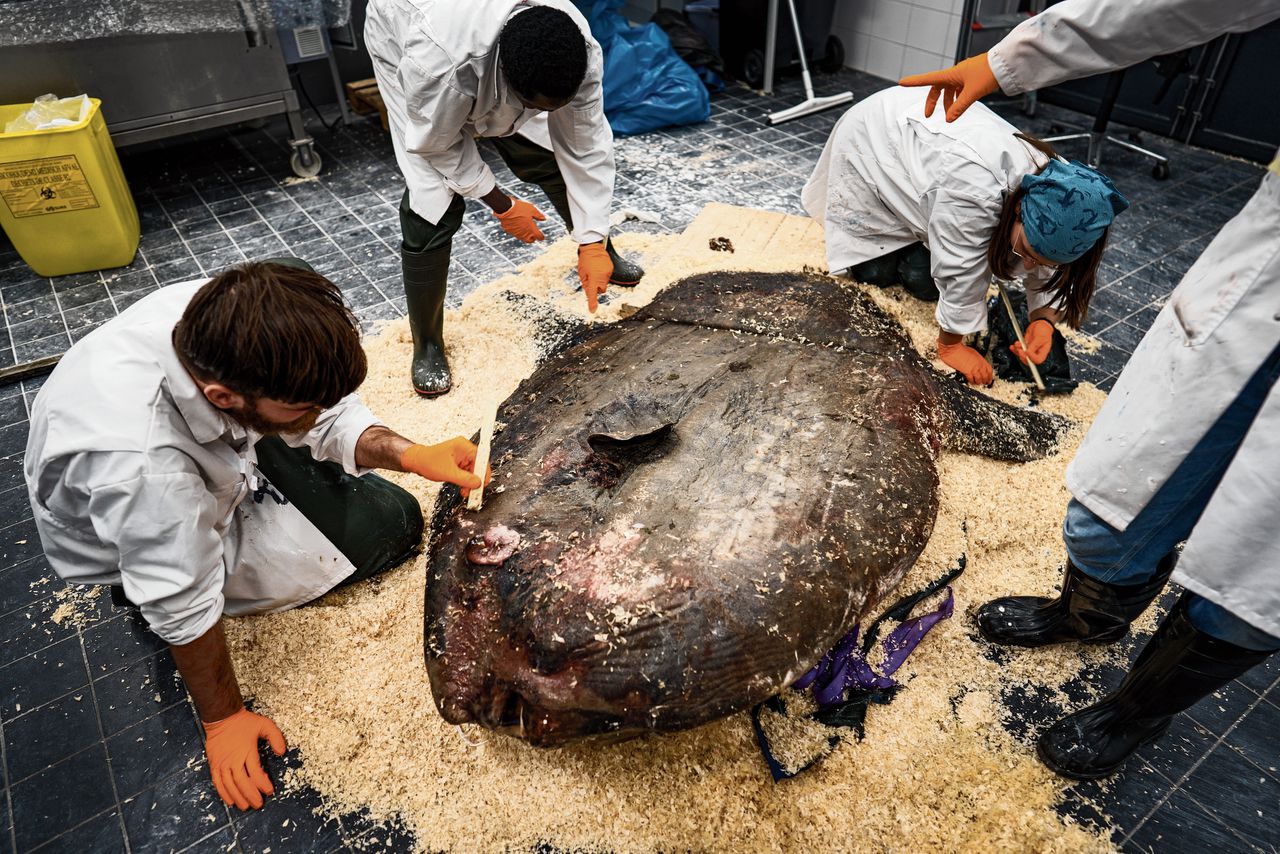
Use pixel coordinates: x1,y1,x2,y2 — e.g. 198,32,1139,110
581,0,712,134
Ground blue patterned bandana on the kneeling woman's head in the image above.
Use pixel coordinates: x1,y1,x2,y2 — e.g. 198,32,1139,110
1023,160,1129,264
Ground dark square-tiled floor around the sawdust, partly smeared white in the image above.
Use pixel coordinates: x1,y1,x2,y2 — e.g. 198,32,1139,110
0,73,1280,854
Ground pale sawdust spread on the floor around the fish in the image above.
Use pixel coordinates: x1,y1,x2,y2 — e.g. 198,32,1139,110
228,215,1126,851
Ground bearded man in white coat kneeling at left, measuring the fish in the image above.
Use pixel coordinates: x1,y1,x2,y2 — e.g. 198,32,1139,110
26,259,480,809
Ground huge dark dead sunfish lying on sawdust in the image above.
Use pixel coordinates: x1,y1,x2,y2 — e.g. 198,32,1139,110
425,273,1065,745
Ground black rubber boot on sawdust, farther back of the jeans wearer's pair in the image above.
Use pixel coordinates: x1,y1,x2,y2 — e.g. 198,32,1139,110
977,554,1178,647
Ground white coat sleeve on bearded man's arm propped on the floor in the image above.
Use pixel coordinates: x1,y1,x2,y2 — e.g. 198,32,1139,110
88,466,225,644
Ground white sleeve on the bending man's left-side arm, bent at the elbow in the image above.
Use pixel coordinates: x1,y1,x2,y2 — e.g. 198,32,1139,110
398,55,497,198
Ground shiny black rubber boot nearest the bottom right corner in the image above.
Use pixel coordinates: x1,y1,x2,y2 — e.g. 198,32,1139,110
1036,594,1271,780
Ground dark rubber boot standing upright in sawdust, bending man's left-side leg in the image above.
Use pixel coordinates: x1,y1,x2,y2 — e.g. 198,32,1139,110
401,245,453,396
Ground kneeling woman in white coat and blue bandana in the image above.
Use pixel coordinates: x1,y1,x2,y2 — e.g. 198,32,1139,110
801,87,1129,385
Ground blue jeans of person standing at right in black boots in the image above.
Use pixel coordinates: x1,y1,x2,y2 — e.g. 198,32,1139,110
1062,338,1280,650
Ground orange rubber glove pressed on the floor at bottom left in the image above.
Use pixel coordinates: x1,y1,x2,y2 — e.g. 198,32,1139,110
205,707,284,809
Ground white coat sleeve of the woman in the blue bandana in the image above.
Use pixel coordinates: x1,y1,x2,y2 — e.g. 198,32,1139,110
928,189,998,335
